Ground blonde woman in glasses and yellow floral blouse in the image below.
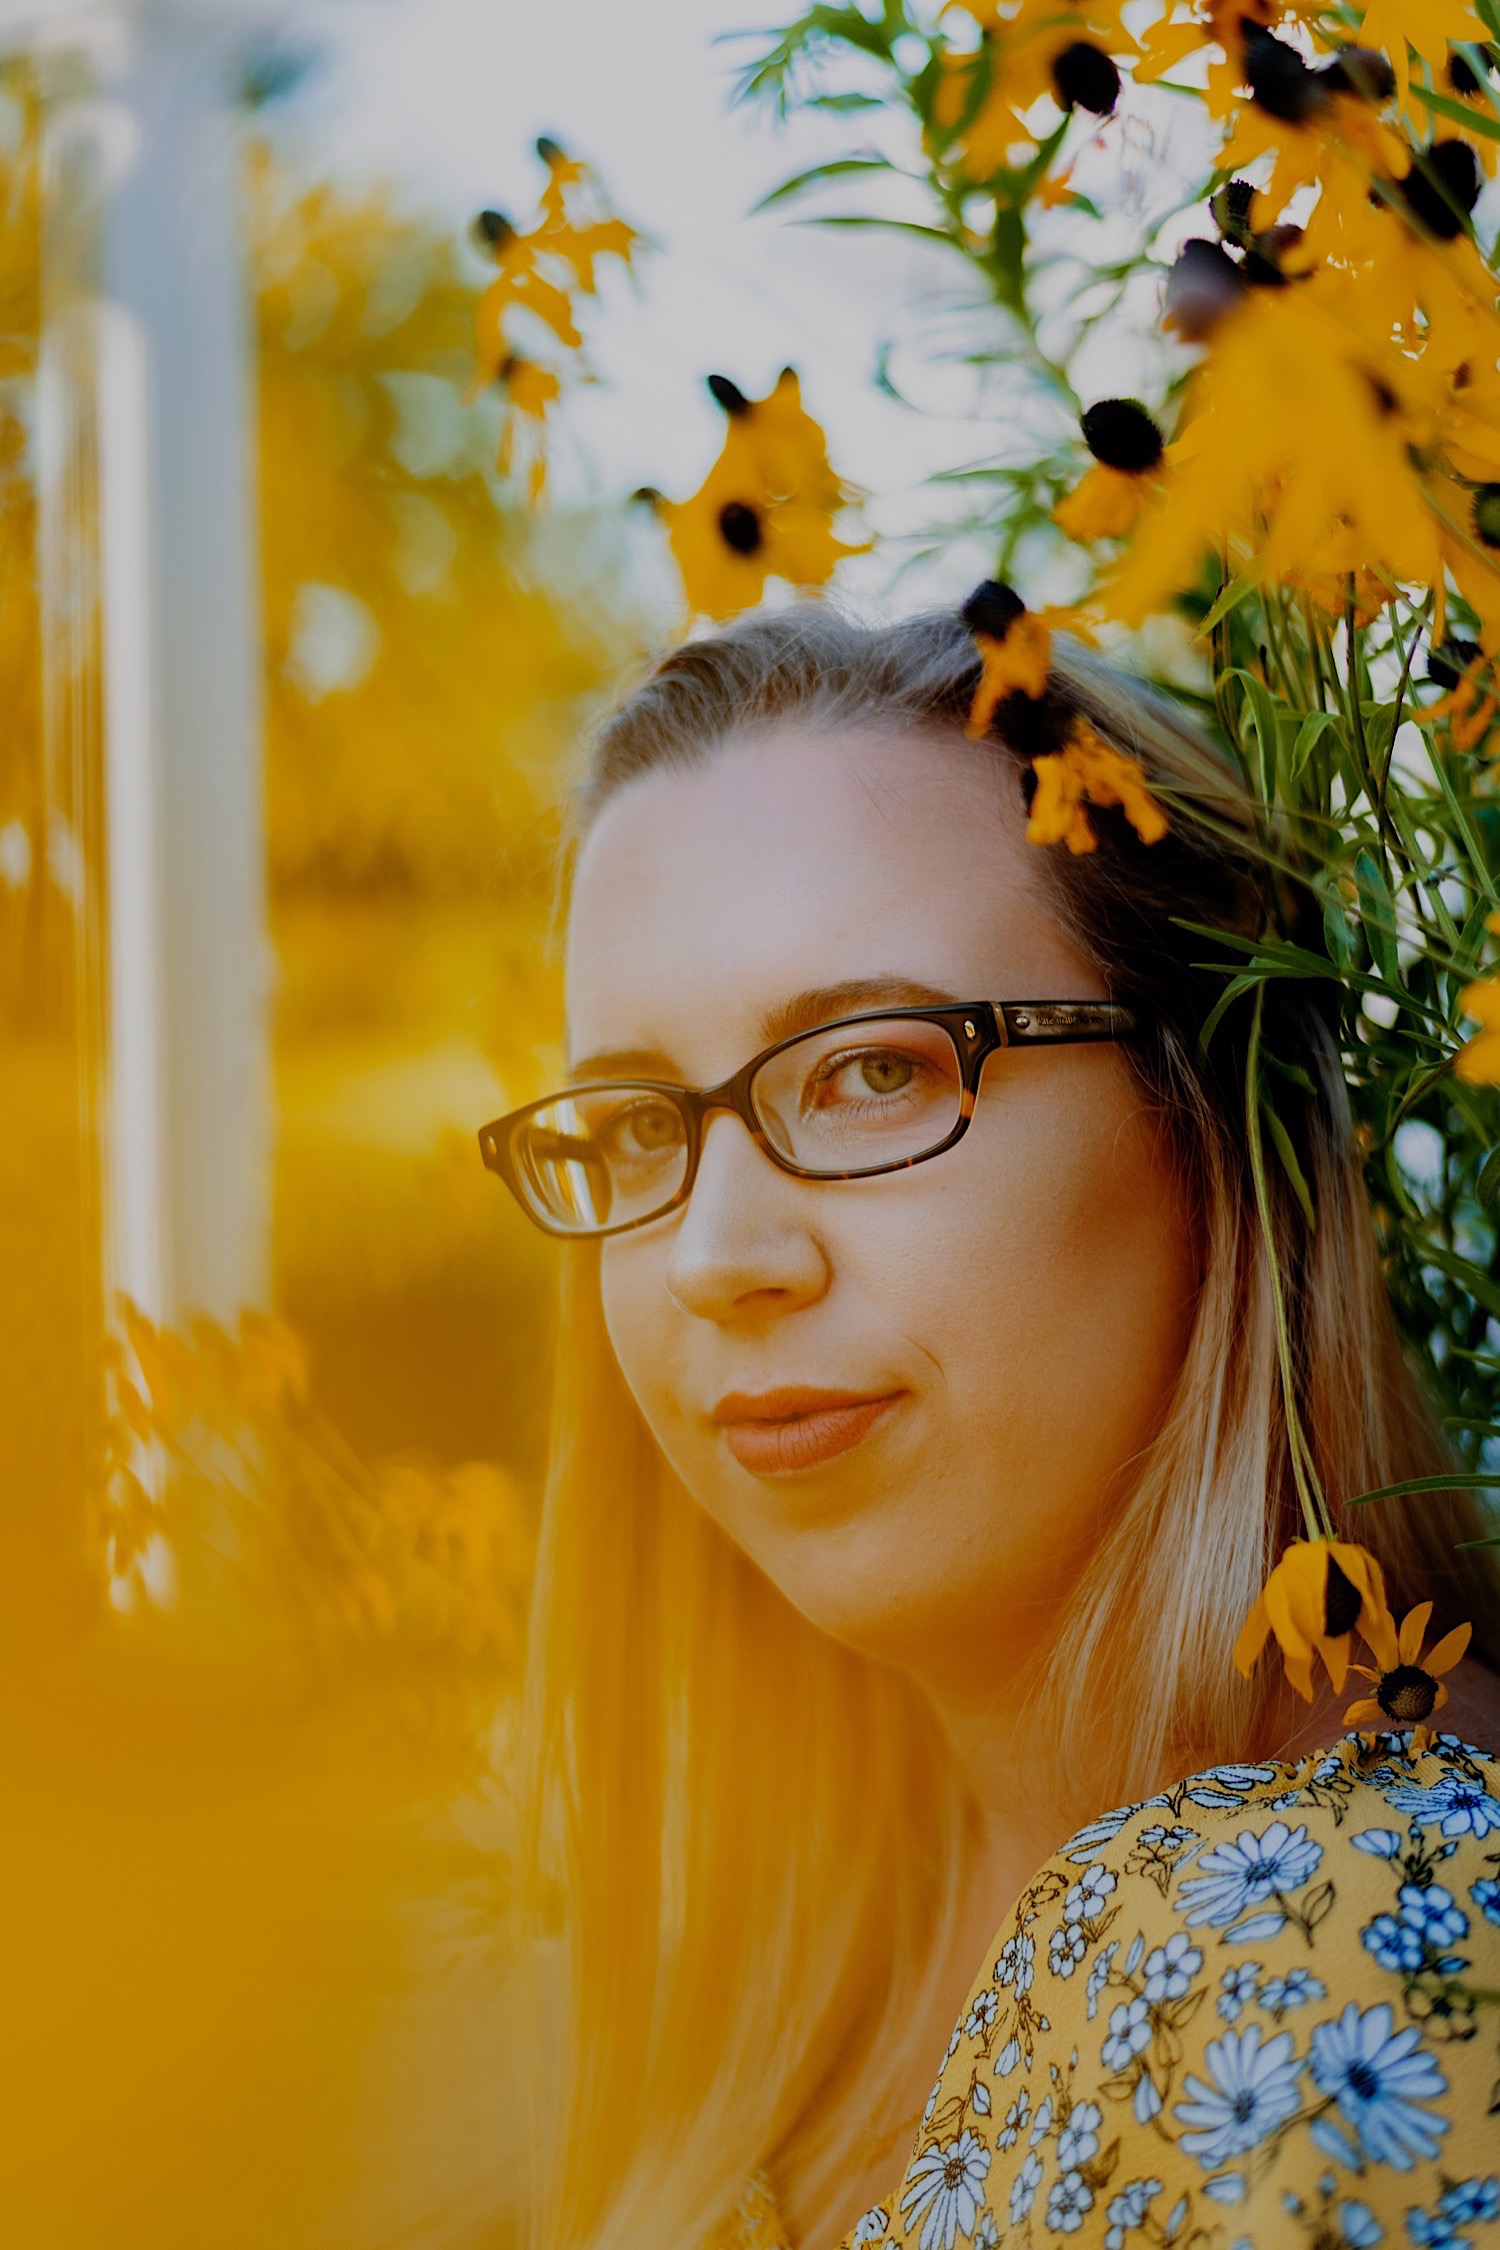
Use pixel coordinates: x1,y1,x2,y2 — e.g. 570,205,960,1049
481,603,1500,2250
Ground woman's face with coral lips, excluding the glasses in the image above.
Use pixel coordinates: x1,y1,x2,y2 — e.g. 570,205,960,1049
567,727,1194,1697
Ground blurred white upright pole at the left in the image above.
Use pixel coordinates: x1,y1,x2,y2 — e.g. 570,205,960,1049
38,0,270,1321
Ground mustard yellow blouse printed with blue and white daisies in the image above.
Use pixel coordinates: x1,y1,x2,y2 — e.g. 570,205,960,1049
724,1735,1500,2250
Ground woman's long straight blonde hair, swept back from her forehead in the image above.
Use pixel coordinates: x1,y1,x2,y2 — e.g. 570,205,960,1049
526,603,1496,2250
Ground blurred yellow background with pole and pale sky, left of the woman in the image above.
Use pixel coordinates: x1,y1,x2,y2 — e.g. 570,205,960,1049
0,0,1007,2250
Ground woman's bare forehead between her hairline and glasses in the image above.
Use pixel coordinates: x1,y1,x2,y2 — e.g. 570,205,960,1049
567,727,1086,1080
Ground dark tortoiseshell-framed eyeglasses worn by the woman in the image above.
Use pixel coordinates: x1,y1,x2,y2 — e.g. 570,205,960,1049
479,999,1136,1238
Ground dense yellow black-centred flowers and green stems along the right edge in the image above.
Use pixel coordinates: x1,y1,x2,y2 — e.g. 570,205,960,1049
742,0,1500,1465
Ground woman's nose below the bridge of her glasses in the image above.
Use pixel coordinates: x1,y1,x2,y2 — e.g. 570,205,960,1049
666,1112,832,1321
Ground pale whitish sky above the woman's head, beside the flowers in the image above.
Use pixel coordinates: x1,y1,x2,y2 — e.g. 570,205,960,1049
281,0,1101,601
